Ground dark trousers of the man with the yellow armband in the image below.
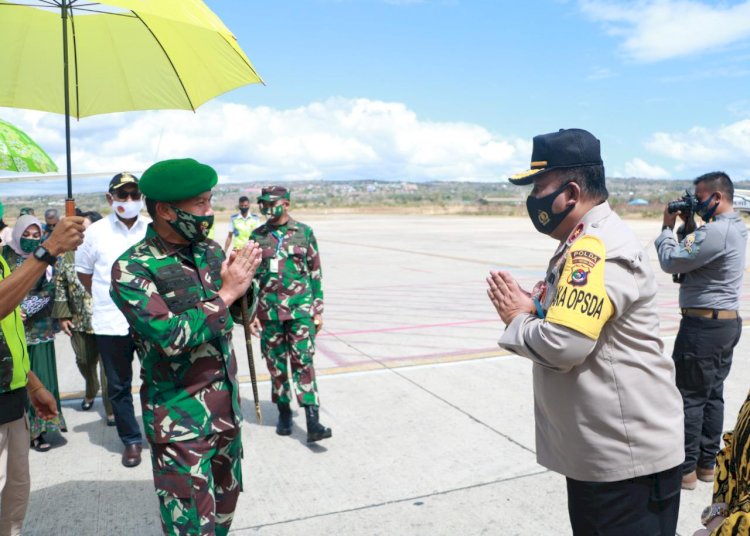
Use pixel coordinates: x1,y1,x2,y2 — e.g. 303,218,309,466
561,466,682,536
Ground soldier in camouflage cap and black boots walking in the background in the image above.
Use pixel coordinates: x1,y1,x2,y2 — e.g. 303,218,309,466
251,186,331,442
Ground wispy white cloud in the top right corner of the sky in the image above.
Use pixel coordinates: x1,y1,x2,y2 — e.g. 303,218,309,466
580,0,750,62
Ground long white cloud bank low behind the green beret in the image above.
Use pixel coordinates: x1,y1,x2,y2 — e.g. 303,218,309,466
0,98,531,181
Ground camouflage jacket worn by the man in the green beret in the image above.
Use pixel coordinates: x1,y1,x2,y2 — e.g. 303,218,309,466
110,224,242,443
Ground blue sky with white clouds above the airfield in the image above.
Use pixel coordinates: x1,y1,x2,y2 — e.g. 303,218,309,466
0,0,750,192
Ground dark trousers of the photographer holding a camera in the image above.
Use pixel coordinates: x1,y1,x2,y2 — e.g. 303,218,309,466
672,316,742,474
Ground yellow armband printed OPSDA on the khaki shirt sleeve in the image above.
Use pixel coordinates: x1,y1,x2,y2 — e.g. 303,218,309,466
546,235,614,339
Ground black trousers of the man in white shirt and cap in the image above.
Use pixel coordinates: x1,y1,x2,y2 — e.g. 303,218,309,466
96,335,143,445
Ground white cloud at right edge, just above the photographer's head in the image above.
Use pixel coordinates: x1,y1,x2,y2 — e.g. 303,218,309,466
646,119,750,176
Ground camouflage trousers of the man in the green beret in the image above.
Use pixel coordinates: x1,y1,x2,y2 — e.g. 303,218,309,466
150,428,242,536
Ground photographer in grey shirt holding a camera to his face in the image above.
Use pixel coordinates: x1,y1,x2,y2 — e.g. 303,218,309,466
655,171,747,489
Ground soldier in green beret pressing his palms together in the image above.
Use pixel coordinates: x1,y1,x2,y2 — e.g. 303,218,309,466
111,159,260,535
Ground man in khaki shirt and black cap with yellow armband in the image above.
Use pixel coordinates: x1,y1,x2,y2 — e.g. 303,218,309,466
487,129,684,536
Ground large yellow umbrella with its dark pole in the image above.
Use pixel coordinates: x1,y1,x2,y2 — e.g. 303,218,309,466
0,0,262,210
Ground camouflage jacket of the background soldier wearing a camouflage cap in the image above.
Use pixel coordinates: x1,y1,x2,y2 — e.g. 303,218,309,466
250,218,323,321
